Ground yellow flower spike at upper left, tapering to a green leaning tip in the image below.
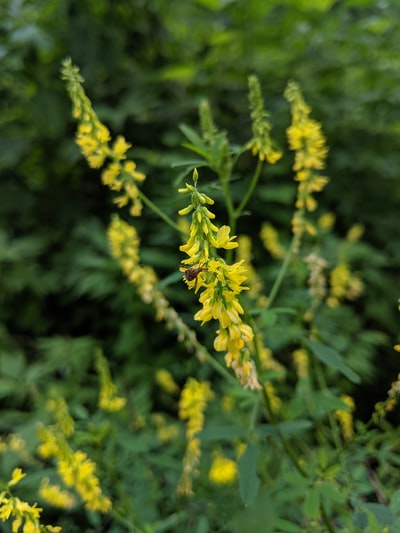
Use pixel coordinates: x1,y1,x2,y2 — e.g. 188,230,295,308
62,59,146,216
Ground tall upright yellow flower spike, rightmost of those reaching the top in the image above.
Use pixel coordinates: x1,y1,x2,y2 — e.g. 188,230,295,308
285,82,328,239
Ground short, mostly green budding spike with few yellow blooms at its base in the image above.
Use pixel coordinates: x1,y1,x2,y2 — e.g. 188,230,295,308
246,76,282,164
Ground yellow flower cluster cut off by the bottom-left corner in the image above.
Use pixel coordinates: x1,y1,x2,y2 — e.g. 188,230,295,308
0,468,61,533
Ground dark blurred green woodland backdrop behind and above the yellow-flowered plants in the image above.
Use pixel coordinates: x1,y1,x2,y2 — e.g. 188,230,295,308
0,0,400,424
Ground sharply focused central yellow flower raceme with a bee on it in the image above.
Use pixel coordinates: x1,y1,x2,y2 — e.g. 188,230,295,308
179,170,260,389
